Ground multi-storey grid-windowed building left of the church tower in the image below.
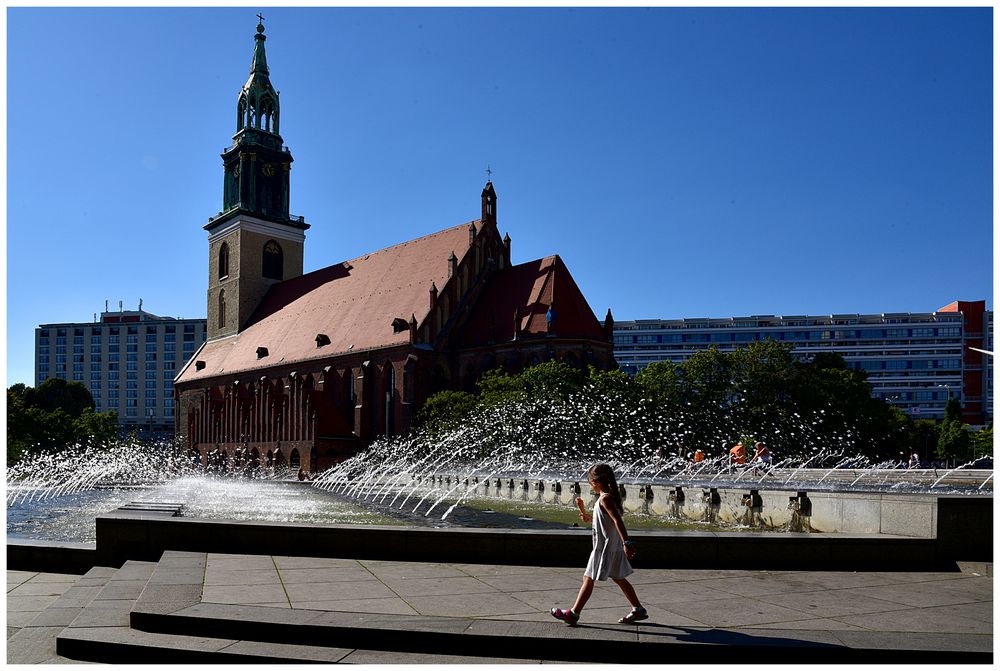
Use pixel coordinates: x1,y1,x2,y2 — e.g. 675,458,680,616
35,303,206,433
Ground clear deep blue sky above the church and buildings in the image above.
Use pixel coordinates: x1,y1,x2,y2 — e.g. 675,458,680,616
7,7,993,385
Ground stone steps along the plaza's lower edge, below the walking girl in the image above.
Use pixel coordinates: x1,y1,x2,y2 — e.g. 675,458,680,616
52,551,992,664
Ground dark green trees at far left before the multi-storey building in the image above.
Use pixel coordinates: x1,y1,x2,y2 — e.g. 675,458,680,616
7,378,118,464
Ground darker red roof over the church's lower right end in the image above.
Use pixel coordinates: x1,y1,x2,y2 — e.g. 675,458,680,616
460,255,605,346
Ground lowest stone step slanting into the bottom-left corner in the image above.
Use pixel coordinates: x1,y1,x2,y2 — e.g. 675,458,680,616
7,566,116,664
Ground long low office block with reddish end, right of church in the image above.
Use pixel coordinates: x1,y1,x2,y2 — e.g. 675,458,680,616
614,301,993,425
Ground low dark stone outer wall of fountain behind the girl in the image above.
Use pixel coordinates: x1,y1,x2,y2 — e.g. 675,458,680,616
29,490,993,570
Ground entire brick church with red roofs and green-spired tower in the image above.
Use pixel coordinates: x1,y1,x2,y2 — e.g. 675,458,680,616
174,25,616,470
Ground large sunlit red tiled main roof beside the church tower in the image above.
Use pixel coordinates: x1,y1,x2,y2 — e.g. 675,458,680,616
178,221,484,383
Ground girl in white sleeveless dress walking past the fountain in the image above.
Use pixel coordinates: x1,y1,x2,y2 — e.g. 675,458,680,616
549,464,649,625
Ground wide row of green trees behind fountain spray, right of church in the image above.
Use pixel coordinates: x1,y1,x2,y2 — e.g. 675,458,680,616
408,340,937,461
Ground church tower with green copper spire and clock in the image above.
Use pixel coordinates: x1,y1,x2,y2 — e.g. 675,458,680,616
205,17,309,340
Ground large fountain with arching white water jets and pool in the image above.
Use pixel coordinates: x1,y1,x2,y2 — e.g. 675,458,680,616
7,390,992,572
